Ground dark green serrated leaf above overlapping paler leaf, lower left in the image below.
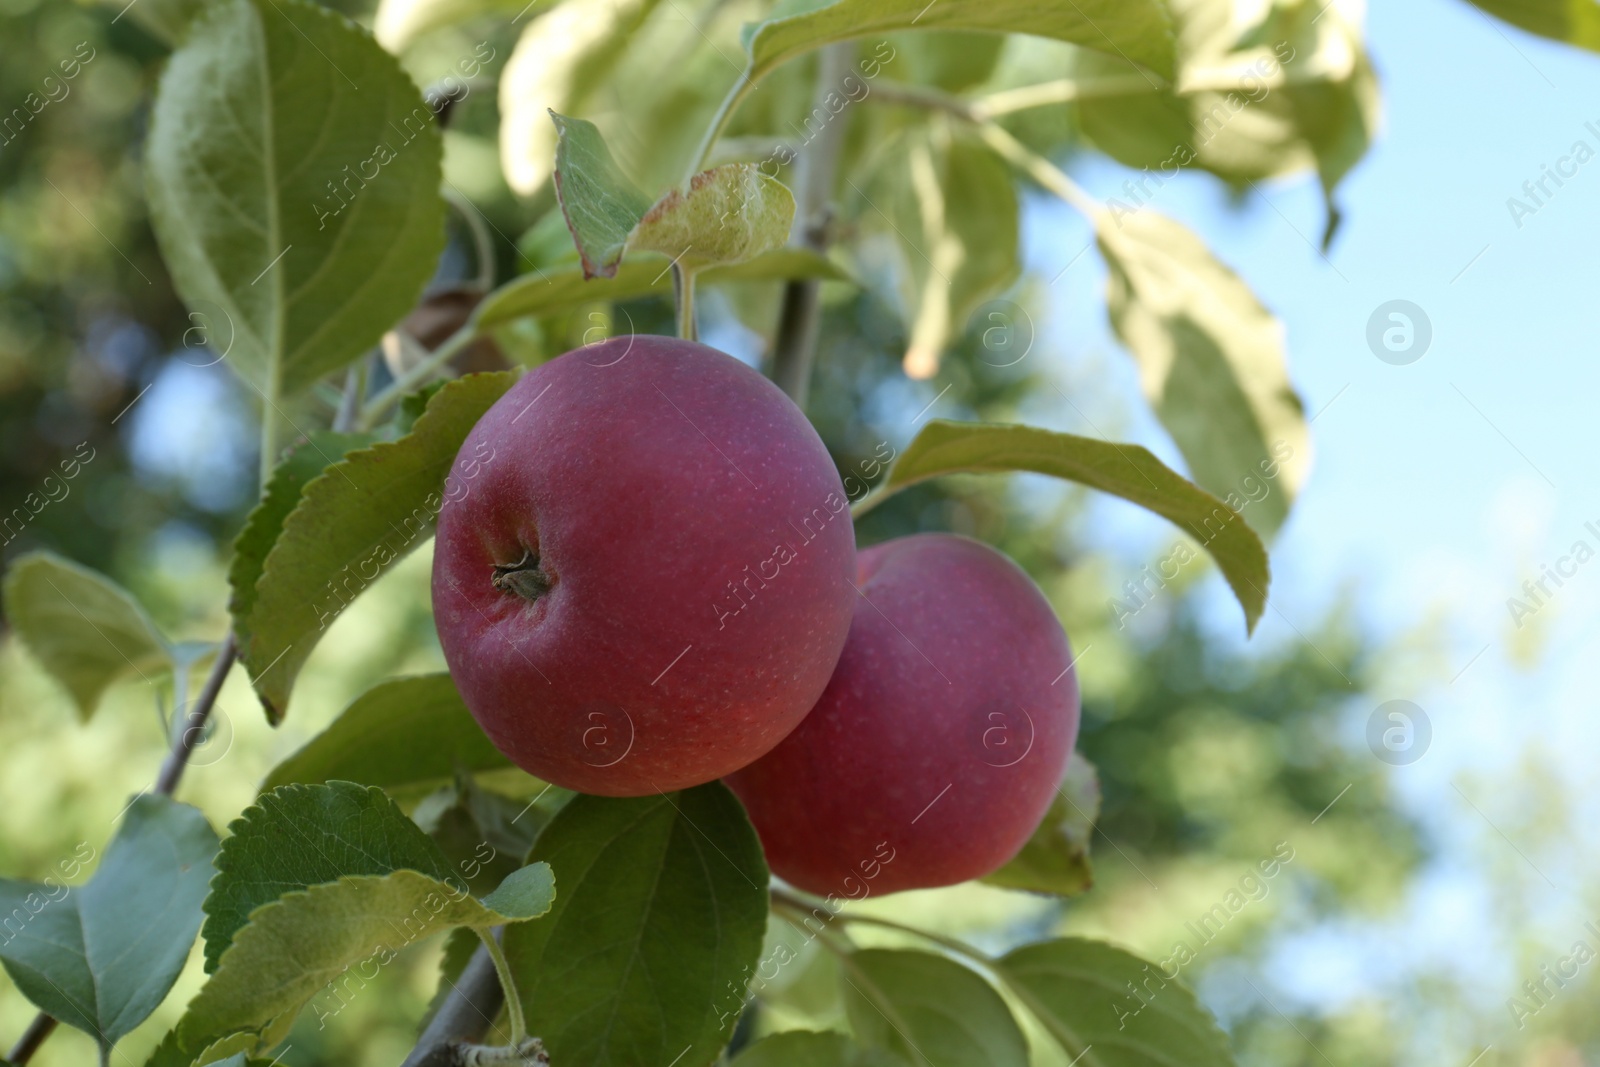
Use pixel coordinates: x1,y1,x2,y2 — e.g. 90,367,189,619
202,782,464,971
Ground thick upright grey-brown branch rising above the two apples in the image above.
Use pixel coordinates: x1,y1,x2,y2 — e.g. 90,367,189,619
773,42,856,408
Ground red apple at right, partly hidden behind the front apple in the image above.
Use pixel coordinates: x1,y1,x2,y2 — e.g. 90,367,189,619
726,534,1078,899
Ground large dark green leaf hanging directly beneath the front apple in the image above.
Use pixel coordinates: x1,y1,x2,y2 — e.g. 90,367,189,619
506,782,768,1067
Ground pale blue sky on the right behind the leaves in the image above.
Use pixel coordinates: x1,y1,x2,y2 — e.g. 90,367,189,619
1004,0,1600,1043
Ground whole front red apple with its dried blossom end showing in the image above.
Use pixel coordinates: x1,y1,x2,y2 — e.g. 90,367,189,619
434,336,856,797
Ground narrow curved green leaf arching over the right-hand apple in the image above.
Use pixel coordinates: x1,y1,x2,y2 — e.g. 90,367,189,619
854,419,1270,629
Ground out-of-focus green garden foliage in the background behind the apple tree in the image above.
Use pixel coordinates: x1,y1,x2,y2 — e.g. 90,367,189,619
0,0,1574,1067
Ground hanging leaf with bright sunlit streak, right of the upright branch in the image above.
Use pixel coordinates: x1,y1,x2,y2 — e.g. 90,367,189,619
862,128,1022,378
